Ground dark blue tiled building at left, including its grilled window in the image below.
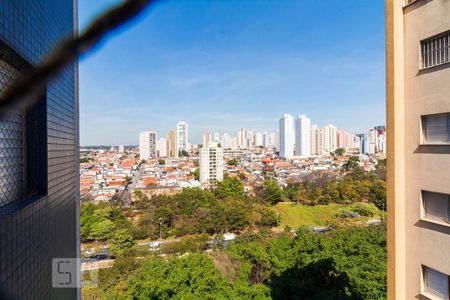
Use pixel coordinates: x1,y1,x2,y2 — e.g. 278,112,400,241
0,0,80,299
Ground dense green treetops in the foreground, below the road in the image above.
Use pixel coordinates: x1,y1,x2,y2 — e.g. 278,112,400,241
83,226,386,299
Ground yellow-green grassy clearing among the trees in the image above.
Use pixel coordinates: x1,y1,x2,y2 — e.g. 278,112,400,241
275,202,378,228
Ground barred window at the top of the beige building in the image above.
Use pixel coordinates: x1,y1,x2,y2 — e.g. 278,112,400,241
420,31,450,69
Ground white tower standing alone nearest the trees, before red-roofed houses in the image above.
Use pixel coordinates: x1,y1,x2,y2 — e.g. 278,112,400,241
199,142,223,188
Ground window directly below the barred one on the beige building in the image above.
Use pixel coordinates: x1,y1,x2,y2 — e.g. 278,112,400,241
422,113,450,144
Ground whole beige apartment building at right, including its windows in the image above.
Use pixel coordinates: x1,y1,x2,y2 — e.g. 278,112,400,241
386,0,450,300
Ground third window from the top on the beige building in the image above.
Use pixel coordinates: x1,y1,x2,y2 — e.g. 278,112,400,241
422,191,450,223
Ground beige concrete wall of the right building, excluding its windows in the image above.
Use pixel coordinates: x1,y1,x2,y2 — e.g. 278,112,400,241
386,0,450,299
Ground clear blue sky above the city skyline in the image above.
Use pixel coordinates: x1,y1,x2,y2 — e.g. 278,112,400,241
79,0,385,145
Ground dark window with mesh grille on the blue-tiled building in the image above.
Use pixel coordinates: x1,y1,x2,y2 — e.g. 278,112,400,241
0,43,47,207
